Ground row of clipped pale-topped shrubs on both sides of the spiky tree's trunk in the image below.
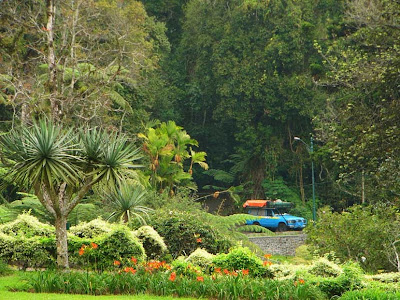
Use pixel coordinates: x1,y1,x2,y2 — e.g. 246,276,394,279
0,214,166,270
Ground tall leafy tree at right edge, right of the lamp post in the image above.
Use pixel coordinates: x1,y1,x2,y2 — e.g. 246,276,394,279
315,0,400,202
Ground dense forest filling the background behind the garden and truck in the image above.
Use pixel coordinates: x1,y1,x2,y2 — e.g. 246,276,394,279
0,0,400,218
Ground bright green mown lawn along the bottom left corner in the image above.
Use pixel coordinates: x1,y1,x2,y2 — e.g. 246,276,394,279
0,273,195,300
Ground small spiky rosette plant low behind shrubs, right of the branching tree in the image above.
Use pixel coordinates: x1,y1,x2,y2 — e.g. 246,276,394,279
106,184,153,225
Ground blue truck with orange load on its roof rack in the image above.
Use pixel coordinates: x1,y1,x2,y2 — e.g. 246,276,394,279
243,200,307,232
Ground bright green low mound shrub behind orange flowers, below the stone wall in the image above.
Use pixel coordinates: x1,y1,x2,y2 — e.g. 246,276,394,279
213,247,272,278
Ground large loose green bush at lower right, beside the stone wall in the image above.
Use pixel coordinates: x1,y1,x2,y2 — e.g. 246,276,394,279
306,204,399,271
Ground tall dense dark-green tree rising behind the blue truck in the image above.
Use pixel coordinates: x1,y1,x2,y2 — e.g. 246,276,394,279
178,0,334,197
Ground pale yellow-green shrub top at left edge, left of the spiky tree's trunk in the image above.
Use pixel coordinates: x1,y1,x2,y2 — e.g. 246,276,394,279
0,213,55,238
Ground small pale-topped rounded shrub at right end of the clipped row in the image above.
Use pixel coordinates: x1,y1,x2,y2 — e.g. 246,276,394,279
134,226,167,259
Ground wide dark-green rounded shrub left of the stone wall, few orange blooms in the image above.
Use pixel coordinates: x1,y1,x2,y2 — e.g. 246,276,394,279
150,211,232,258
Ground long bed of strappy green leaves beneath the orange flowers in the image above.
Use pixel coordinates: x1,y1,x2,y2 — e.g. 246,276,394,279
25,271,326,300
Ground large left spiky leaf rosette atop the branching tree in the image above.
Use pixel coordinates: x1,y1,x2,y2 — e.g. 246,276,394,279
0,120,81,187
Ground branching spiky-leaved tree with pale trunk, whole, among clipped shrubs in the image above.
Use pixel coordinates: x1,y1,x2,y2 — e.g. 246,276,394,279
0,120,139,268
